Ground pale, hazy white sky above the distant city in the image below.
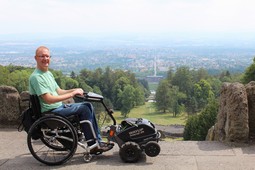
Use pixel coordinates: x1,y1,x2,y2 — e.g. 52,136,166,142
0,0,255,37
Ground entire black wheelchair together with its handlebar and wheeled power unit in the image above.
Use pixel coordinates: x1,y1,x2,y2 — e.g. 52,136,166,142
27,92,161,165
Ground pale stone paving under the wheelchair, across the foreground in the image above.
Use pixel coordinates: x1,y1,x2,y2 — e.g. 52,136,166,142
0,129,255,170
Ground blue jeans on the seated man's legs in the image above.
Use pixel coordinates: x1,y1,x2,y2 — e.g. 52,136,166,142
52,102,102,146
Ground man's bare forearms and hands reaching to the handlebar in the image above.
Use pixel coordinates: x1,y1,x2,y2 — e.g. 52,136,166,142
41,88,83,104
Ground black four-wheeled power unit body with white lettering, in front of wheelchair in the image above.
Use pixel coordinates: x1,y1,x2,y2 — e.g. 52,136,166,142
109,118,161,162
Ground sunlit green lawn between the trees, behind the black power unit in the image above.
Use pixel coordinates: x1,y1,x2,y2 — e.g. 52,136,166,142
110,103,187,125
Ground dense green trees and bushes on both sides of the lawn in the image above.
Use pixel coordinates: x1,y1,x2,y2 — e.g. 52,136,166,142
0,58,255,140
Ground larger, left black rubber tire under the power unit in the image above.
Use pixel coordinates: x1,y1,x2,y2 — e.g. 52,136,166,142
119,142,142,163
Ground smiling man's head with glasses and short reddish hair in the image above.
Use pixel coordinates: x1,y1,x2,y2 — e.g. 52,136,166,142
35,46,51,71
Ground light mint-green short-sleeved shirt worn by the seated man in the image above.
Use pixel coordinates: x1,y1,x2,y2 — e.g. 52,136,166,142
29,69,62,113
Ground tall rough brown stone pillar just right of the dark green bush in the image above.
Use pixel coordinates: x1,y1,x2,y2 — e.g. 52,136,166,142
214,83,249,142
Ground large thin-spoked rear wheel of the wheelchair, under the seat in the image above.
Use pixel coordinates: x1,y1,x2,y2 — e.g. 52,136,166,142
27,115,78,165
